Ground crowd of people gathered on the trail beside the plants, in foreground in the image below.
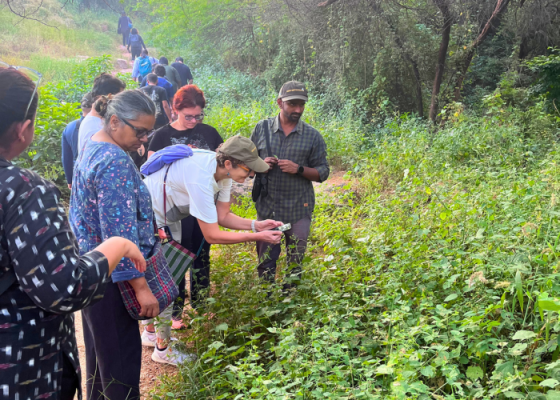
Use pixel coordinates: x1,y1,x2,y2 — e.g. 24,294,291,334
0,52,329,400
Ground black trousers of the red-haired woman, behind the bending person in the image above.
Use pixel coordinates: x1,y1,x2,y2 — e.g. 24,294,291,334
173,216,210,319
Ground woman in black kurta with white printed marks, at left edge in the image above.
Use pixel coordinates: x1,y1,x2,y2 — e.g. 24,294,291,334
0,67,146,400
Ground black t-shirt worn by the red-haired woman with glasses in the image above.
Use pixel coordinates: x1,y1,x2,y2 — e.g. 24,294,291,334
148,123,224,151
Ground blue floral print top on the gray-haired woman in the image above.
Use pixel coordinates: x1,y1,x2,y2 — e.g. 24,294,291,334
70,140,156,282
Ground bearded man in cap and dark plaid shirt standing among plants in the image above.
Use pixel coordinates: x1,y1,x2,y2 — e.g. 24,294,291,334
251,81,329,282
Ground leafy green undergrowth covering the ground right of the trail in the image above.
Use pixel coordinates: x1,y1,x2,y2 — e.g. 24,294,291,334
153,96,560,399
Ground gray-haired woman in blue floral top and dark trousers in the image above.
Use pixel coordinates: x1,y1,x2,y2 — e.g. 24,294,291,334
70,90,160,400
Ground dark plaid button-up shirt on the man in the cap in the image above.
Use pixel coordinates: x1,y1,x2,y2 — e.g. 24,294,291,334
251,116,329,223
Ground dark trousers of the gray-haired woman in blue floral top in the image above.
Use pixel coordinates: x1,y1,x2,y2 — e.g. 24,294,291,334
82,283,142,400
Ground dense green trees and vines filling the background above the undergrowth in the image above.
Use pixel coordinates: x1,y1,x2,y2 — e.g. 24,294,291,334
135,0,560,123
